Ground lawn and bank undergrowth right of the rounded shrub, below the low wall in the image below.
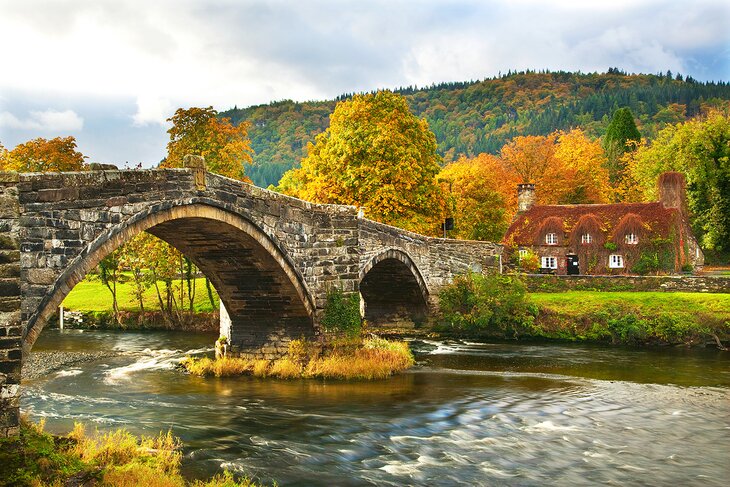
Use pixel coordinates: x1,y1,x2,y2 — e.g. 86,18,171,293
528,291,730,345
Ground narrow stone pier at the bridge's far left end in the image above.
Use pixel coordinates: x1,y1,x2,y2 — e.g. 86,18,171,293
0,172,22,437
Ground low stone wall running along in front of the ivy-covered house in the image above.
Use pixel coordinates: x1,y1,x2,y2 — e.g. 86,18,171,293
525,274,730,293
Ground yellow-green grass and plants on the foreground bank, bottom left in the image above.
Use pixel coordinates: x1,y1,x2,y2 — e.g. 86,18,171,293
0,420,255,487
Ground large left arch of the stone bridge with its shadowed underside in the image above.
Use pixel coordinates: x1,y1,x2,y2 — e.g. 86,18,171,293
23,199,315,354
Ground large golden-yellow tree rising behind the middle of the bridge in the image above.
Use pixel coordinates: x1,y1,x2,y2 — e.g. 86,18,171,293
277,91,441,232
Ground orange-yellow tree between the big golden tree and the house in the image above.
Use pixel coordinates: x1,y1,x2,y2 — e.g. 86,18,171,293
437,154,519,241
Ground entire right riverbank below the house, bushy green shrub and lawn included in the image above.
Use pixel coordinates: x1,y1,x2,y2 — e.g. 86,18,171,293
436,274,730,348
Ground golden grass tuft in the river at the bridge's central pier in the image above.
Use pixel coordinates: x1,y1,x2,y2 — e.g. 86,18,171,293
182,338,414,380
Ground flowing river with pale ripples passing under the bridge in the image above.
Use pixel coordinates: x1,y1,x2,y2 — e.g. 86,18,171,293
22,330,730,486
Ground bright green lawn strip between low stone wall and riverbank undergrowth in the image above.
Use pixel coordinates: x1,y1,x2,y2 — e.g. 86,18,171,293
528,291,730,320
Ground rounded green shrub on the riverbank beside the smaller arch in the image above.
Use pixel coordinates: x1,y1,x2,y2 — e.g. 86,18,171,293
439,274,536,336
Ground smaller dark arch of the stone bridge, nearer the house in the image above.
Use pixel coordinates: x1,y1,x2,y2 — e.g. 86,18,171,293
360,248,430,324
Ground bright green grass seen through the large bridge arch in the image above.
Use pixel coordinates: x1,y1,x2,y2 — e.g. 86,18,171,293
63,274,218,312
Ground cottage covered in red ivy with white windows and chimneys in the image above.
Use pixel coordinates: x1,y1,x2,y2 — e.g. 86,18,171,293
503,172,704,274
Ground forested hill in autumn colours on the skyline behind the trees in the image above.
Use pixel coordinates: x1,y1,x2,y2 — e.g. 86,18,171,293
221,68,730,187
